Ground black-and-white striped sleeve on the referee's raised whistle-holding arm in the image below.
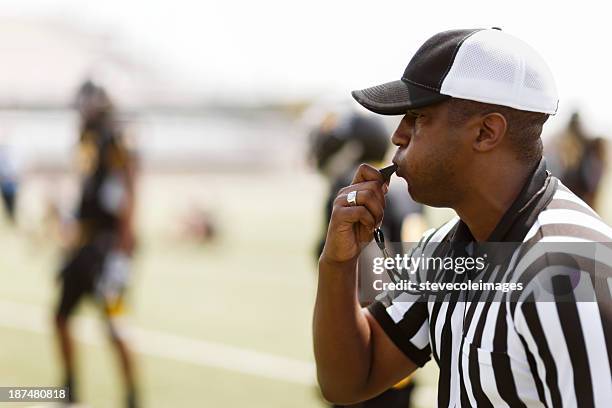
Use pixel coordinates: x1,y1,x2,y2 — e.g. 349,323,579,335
368,293,431,367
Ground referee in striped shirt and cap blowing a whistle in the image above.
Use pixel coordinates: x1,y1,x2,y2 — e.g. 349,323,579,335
314,29,612,407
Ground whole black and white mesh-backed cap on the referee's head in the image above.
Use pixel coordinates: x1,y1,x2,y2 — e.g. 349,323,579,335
352,28,559,115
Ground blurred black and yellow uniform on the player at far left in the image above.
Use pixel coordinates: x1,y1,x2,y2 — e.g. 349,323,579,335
58,123,131,316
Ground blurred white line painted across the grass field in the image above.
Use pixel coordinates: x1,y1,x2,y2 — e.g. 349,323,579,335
0,300,315,386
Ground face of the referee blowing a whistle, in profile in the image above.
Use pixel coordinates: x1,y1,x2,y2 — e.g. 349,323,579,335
391,102,471,207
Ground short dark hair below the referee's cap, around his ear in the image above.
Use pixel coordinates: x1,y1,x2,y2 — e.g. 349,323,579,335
448,98,549,164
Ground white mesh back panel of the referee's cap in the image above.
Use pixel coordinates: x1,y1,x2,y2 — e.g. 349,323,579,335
440,30,558,114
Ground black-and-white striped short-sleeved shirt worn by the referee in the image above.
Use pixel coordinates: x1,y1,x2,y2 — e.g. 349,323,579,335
369,163,612,407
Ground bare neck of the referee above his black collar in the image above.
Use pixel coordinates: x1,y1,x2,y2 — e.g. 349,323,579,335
454,164,531,242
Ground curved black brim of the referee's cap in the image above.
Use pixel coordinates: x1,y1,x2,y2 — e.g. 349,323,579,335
351,80,450,115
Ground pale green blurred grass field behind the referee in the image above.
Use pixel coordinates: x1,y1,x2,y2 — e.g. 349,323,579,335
0,175,330,407
